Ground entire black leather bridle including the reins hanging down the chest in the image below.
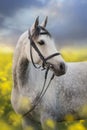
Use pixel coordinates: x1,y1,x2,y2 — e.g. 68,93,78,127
23,26,60,117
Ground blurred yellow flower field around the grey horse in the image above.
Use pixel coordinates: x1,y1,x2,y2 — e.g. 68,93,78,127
0,46,87,130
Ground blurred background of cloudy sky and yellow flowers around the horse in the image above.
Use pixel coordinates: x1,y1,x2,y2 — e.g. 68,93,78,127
0,0,87,130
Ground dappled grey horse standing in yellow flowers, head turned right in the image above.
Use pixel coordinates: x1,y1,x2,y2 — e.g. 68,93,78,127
11,18,87,130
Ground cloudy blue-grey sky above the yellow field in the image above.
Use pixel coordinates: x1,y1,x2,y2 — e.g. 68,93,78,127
0,0,87,45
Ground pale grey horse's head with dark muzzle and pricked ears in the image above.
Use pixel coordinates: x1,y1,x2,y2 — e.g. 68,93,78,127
27,17,67,76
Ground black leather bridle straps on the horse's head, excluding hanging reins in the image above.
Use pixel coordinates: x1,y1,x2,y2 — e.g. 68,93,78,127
29,26,60,69
